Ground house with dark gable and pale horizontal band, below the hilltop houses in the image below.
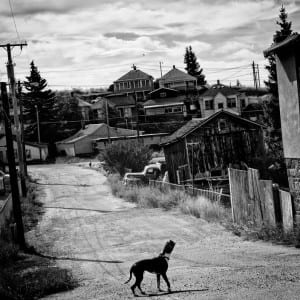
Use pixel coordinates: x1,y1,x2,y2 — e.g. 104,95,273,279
143,88,186,119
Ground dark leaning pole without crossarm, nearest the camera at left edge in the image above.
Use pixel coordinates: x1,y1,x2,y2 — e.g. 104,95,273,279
1,82,26,249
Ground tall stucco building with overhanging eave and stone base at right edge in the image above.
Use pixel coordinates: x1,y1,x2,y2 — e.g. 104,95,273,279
264,33,300,224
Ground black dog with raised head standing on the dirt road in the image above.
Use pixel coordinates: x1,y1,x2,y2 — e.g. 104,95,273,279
125,240,175,296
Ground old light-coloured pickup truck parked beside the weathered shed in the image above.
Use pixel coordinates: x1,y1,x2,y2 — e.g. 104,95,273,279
123,163,161,185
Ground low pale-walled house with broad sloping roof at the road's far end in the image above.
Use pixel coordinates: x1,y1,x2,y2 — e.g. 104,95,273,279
56,123,136,156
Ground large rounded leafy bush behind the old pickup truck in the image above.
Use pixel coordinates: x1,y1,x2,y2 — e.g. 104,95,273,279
99,141,152,176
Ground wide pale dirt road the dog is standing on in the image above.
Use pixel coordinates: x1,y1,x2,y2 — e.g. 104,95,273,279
27,164,300,300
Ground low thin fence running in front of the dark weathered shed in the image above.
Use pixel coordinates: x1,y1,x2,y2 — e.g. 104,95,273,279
150,180,230,203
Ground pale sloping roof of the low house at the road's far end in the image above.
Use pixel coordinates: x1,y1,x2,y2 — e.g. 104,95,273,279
56,123,137,144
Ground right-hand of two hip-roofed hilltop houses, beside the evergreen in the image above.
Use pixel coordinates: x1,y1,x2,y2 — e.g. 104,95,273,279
159,66,197,91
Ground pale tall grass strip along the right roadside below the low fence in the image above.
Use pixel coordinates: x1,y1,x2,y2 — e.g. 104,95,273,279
108,174,230,222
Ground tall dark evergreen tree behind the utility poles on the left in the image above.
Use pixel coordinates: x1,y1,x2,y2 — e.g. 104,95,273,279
23,61,58,143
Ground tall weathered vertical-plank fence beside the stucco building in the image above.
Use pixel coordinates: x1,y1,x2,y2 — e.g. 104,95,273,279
228,168,293,232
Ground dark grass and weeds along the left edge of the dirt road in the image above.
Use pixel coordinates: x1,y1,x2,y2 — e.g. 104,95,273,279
0,180,78,300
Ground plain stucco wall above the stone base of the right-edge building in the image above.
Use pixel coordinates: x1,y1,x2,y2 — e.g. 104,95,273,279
276,52,300,158
